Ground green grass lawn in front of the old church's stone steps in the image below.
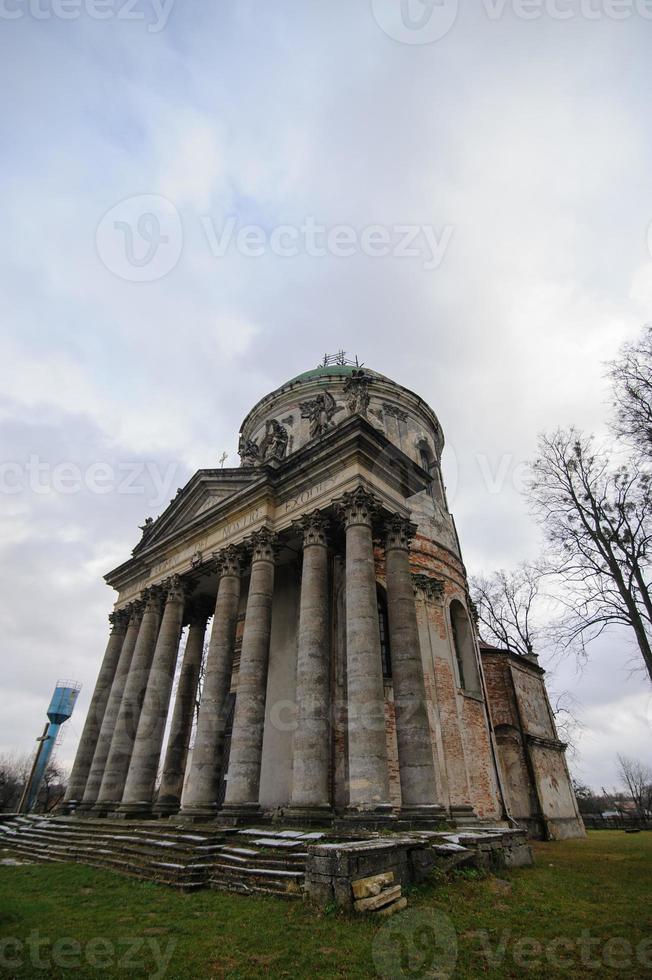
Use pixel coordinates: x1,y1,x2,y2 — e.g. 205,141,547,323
0,831,652,980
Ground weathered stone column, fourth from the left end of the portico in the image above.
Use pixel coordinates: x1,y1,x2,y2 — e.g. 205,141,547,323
120,575,187,818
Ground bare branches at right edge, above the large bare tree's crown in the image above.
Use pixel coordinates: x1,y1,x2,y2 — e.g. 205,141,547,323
609,326,652,459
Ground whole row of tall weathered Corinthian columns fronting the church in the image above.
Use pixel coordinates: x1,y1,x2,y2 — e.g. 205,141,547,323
64,486,440,820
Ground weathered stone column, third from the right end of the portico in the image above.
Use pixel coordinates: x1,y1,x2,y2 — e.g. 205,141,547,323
290,511,331,820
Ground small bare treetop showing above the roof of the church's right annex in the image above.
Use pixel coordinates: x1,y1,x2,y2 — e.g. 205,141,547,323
471,562,541,656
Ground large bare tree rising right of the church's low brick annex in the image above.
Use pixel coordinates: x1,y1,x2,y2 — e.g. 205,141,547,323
528,428,652,680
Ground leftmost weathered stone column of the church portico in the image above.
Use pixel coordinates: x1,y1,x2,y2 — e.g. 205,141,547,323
61,609,129,812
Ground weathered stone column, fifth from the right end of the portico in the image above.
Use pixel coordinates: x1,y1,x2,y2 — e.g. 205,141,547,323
181,547,242,820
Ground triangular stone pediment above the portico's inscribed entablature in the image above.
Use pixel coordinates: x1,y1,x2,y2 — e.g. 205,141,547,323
133,469,259,555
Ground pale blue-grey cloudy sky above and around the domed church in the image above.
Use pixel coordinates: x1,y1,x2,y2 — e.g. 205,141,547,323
0,0,652,786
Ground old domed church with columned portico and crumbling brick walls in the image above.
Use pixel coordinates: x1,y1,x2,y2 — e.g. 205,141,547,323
66,356,582,835
